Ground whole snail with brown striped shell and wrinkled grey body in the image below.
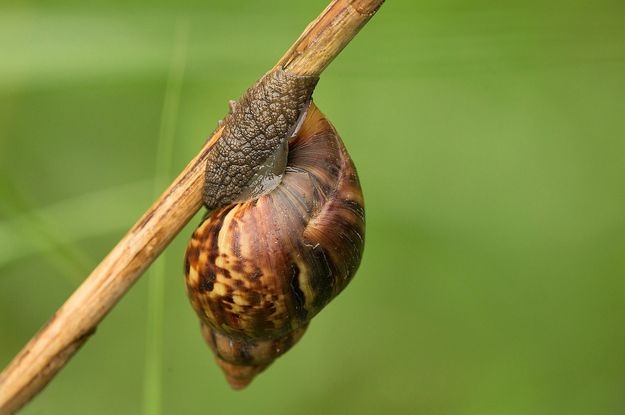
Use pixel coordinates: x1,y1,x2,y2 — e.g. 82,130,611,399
185,69,365,389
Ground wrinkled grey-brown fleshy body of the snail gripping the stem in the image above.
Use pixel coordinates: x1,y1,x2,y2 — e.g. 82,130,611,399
204,69,319,209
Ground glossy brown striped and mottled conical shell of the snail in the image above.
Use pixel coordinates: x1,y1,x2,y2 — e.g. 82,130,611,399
185,103,365,389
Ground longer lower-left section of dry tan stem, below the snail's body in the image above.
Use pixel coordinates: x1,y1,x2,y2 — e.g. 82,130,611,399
0,130,221,415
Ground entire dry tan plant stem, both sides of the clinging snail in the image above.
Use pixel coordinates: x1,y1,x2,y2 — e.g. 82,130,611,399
0,0,384,415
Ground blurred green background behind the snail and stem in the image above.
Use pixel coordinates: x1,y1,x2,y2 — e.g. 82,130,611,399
0,0,625,415
